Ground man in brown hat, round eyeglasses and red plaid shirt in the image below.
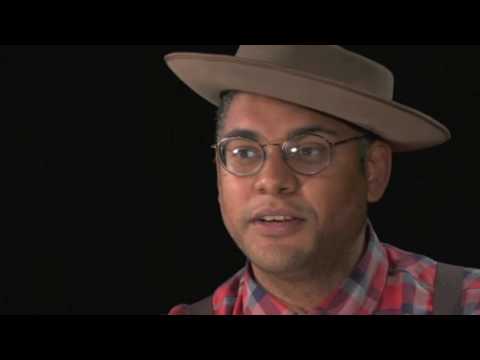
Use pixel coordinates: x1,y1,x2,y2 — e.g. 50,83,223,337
166,45,480,315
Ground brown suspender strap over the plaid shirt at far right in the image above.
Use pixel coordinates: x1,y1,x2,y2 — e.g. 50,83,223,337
433,263,465,315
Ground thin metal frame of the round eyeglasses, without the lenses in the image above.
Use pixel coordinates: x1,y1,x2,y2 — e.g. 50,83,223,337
211,132,375,177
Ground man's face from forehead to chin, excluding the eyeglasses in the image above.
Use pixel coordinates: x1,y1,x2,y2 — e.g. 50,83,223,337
217,93,367,276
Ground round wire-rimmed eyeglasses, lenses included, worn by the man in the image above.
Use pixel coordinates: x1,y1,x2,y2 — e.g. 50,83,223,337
212,133,369,177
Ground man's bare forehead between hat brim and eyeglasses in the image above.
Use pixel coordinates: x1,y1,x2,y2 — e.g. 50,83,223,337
223,93,353,138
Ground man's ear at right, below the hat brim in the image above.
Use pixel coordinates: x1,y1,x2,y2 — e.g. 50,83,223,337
366,141,392,203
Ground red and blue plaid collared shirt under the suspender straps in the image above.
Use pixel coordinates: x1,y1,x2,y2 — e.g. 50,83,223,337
169,222,480,315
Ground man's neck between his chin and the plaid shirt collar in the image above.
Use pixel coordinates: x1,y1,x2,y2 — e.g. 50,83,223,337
252,225,366,313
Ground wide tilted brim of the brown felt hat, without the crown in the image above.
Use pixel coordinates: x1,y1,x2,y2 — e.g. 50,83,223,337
165,53,451,152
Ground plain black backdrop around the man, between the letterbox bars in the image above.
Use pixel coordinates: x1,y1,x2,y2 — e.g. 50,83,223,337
0,45,480,314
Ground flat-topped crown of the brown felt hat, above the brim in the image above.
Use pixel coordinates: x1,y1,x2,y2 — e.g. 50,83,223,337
236,45,394,100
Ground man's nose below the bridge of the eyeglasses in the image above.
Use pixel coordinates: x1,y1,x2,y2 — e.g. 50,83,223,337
255,146,299,196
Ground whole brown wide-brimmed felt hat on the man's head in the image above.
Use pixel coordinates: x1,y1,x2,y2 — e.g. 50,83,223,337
165,45,451,152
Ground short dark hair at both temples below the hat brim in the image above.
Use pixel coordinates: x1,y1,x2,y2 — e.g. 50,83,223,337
215,90,379,175
